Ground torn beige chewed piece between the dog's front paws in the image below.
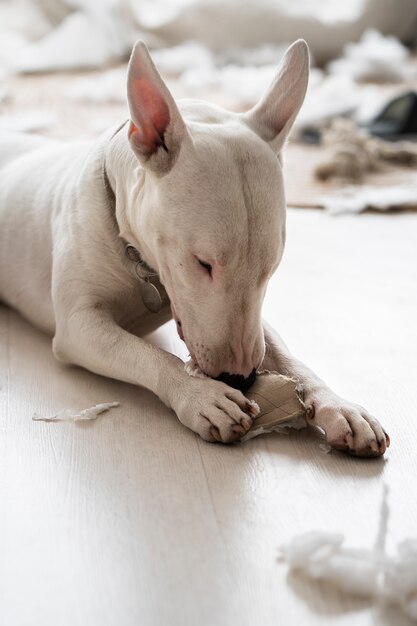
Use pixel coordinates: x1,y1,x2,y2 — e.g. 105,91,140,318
241,370,307,441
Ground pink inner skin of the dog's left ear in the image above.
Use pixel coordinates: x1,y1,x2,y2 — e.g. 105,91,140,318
129,77,170,154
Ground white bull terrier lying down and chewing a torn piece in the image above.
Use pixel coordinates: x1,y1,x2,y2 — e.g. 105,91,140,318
0,41,389,456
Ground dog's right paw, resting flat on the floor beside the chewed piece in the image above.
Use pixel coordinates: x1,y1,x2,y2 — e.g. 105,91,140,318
306,391,390,457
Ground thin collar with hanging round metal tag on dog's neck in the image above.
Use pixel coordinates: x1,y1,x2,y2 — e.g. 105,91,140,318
102,128,167,313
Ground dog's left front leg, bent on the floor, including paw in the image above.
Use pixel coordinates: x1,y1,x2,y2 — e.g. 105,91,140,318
53,307,254,443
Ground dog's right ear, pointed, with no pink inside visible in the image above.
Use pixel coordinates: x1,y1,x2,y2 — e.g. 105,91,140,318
242,39,309,152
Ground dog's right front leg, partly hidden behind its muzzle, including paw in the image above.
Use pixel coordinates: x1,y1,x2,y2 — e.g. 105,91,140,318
262,322,389,456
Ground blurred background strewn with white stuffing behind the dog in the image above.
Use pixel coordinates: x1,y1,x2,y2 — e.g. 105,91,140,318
0,0,417,213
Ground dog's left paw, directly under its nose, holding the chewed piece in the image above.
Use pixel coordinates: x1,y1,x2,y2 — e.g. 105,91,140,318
175,377,259,443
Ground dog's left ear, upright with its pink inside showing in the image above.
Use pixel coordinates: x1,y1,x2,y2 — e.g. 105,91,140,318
127,41,187,175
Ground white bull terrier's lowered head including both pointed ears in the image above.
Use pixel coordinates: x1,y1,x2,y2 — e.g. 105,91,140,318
128,41,309,388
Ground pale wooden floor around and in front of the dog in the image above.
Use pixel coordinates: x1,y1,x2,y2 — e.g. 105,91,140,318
0,210,417,626
